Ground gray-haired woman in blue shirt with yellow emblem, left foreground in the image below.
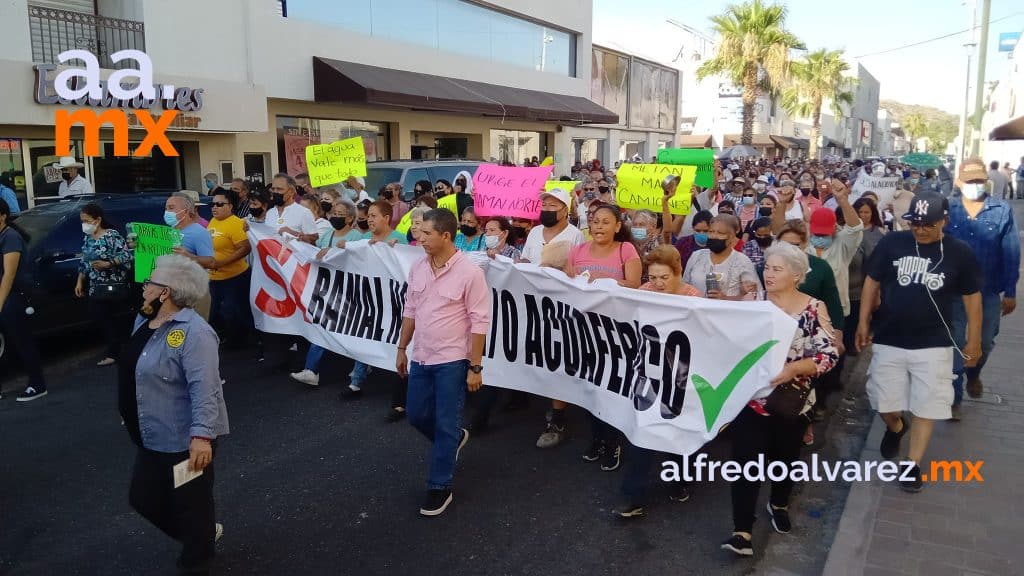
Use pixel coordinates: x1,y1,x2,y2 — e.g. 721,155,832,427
118,254,228,574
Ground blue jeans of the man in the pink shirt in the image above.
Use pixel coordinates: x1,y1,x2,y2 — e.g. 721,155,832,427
406,360,469,490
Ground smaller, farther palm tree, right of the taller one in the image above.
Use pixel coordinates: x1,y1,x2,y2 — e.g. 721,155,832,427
782,49,856,158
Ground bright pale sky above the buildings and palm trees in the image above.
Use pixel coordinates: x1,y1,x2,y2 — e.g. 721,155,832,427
594,0,1024,116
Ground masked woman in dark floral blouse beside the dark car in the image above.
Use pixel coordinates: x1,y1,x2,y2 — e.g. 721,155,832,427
75,203,132,366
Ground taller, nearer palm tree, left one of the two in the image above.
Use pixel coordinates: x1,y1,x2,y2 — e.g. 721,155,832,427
697,0,804,146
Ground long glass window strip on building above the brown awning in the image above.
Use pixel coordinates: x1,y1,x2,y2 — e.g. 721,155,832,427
284,0,577,77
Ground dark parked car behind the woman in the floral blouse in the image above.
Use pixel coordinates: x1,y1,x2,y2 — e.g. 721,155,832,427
0,191,210,365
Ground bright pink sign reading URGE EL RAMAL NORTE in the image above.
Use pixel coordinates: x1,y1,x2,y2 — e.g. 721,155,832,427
473,164,555,220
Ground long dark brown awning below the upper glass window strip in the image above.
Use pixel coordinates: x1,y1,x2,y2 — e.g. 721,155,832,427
313,56,618,124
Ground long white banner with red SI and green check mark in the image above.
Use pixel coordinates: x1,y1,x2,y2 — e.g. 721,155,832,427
249,224,796,454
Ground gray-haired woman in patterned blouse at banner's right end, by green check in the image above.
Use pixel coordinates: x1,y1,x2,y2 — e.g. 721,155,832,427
722,242,839,556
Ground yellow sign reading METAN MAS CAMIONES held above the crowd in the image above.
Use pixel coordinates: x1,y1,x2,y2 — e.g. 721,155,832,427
615,164,697,214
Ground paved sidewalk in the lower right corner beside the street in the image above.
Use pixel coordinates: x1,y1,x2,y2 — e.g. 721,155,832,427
824,303,1024,576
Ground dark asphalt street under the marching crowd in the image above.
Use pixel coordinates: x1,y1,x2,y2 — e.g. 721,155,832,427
0,317,866,575
